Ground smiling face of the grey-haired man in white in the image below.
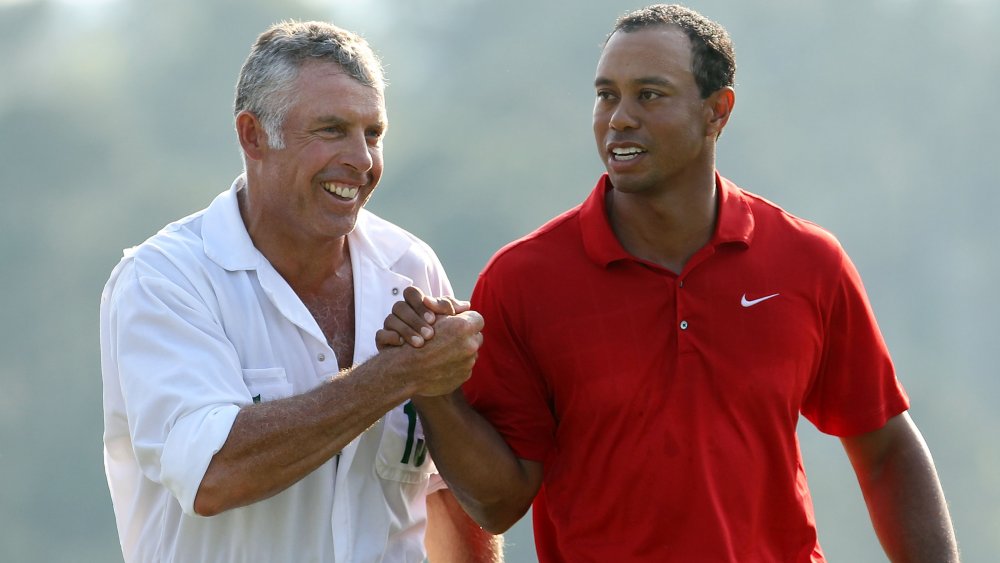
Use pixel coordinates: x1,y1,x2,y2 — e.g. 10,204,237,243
237,62,387,253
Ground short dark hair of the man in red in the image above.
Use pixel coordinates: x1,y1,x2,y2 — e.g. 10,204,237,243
604,4,736,98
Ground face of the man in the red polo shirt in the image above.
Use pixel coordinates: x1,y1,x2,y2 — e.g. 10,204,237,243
594,25,721,198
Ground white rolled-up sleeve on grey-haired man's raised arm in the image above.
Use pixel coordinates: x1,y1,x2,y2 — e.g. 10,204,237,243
109,265,244,516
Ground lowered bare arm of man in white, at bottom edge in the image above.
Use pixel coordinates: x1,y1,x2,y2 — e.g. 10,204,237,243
424,489,503,563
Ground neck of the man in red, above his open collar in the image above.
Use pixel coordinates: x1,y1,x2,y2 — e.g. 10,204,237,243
606,170,718,274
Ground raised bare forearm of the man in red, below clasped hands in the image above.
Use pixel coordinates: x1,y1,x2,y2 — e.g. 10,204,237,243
413,390,541,534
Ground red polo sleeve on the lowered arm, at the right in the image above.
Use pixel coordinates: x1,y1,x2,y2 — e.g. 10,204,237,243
802,251,909,436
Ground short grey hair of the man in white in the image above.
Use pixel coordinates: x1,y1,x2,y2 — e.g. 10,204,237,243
233,21,385,149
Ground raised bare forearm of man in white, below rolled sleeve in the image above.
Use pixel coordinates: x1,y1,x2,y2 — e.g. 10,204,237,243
194,352,410,516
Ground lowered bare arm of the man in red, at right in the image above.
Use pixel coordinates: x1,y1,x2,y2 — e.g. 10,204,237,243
841,412,959,562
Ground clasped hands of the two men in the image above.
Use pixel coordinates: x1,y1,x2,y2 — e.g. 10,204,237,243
375,287,483,397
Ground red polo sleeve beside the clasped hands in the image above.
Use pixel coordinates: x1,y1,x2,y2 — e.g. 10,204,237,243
463,270,556,461
